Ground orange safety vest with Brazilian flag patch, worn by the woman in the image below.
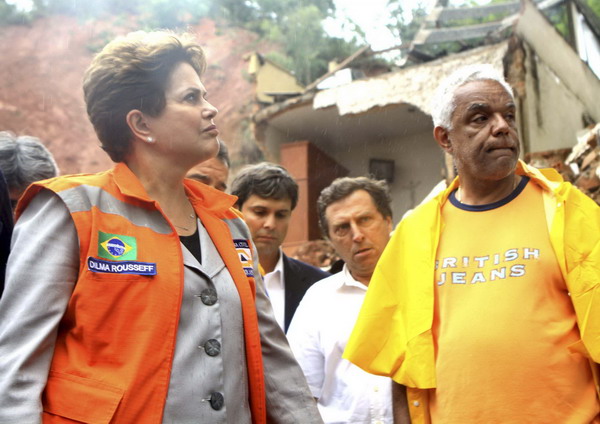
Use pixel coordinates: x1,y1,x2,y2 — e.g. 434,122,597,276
17,163,266,424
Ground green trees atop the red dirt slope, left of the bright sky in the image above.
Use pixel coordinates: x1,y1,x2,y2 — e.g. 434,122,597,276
0,0,359,84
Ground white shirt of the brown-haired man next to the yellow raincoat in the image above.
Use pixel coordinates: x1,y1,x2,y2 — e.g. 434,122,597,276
287,265,393,424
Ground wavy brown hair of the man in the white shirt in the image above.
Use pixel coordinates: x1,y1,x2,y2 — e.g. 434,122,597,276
317,177,392,238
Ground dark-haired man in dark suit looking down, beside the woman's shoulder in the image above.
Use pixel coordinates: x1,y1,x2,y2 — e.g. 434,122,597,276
231,162,329,331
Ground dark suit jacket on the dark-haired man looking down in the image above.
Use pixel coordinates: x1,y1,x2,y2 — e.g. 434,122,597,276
283,255,330,333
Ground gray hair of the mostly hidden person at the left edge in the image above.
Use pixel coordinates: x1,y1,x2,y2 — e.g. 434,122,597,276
0,131,58,191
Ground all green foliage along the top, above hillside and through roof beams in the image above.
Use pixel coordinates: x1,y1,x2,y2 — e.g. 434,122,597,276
0,0,600,84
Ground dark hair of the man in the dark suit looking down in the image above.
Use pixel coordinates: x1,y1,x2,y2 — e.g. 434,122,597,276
231,162,298,210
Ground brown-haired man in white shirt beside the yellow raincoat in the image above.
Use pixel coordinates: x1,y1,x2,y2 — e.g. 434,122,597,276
288,177,393,424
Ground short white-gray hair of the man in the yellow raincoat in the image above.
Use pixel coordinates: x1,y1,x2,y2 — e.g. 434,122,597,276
431,64,514,130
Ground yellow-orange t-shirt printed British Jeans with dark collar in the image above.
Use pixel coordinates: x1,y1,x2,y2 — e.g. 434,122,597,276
430,179,599,424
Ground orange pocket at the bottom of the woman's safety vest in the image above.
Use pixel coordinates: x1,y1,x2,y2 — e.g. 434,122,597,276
42,371,124,424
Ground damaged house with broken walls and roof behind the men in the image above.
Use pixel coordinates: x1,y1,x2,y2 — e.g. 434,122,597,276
248,0,600,251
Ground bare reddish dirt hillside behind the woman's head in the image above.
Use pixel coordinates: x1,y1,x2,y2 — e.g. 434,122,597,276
0,16,273,174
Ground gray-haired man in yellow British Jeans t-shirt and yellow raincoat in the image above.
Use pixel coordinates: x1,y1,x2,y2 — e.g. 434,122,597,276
344,65,600,424
